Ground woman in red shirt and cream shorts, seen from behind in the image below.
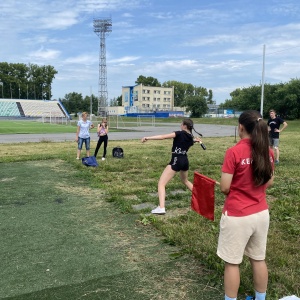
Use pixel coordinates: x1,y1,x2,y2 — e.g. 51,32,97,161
217,110,274,300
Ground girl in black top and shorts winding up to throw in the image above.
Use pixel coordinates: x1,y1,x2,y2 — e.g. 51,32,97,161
142,119,202,214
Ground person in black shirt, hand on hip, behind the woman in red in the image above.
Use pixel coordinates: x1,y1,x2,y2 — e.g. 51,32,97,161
268,109,288,164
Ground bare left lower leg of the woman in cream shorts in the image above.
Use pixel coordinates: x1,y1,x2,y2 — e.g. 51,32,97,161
224,263,240,298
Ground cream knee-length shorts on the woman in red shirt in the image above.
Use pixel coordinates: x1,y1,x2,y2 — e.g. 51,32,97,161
217,210,270,264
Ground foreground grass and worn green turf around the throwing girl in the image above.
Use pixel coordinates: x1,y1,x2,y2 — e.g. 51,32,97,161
0,120,300,300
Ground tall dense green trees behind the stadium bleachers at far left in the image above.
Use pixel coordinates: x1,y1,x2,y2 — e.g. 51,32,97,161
0,62,57,99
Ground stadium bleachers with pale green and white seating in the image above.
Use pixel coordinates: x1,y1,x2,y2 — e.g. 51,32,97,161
0,99,70,119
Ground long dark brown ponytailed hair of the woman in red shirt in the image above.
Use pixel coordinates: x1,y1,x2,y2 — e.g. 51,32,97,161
239,110,273,186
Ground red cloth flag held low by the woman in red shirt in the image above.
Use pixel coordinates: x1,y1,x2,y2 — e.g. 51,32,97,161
191,172,216,221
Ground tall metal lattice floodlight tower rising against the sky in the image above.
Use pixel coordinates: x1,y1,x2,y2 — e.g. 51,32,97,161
93,18,112,116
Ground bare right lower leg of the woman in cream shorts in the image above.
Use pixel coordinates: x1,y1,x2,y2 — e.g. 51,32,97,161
249,258,268,293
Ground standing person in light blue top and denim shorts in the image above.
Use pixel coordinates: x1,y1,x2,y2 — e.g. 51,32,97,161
75,112,94,159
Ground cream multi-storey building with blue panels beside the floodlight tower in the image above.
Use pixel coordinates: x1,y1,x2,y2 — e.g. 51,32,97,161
122,84,174,113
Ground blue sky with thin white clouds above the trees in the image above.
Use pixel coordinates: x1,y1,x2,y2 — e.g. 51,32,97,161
0,0,300,103
